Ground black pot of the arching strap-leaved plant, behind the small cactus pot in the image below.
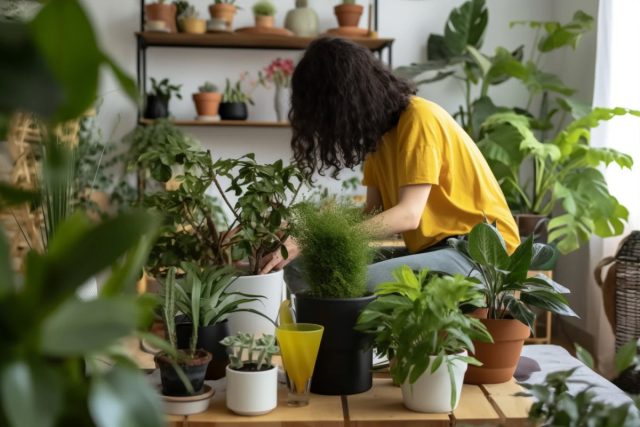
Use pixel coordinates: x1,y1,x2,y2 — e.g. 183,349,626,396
176,316,229,380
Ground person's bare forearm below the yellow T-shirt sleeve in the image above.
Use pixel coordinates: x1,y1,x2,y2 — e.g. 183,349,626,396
364,184,431,238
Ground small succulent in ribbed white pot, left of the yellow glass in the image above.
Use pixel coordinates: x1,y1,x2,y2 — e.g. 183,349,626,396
222,334,279,415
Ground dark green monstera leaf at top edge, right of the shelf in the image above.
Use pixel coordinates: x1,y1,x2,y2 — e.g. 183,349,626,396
444,0,489,55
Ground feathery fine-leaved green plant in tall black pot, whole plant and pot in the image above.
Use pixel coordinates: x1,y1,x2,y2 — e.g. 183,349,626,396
293,204,375,395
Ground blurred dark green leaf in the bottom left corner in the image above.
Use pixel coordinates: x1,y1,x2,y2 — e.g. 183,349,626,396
0,361,64,427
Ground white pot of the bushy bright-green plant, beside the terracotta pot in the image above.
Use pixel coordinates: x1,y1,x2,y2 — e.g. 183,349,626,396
402,351,467,413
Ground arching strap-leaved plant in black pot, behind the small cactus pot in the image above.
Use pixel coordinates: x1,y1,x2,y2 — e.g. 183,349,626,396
170,262,263,380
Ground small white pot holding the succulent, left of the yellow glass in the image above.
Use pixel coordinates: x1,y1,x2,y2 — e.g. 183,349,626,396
227,366,278,415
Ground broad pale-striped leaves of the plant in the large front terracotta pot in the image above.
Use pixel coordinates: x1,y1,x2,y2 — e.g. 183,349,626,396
449,223,577,331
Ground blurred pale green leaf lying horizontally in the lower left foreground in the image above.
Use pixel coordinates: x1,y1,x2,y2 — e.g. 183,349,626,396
40,297,138,356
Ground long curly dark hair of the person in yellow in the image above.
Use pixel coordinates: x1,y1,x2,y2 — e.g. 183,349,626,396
289,37,415,176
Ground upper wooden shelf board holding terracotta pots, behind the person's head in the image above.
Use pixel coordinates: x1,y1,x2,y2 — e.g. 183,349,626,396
136,31,394,52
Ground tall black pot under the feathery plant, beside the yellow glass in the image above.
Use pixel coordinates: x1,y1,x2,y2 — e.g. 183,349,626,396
295,293,375,395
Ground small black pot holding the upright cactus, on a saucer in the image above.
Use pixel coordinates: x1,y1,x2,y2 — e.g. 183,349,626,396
155,350,211,396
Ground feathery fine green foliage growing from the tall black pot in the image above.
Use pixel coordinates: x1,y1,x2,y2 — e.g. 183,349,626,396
293,203,373,298
